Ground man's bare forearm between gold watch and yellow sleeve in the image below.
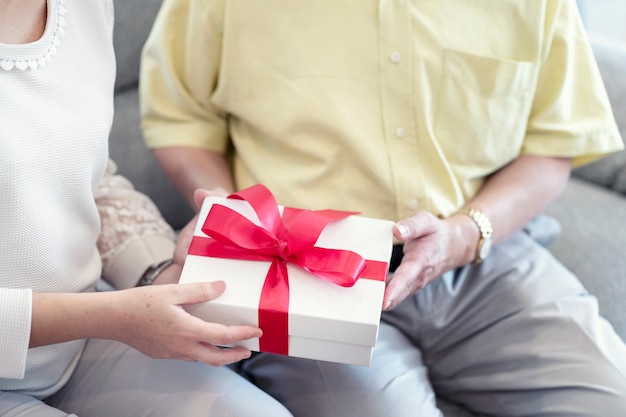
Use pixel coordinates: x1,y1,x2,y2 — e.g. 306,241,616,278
467,155,571,243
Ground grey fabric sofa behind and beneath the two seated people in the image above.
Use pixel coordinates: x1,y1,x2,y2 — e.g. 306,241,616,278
110,0,626,417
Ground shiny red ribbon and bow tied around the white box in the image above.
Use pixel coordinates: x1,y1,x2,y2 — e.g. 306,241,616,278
189,184,387,355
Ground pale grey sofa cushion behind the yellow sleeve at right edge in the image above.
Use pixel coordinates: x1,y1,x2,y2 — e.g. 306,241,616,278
573,35,626,194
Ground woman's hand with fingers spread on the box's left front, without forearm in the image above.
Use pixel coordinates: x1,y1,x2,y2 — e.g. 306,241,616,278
111,281,262,366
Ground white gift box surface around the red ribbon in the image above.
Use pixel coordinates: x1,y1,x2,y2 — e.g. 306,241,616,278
180,192,393,366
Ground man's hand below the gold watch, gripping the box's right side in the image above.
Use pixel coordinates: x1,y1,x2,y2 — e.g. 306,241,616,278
383,211,479,310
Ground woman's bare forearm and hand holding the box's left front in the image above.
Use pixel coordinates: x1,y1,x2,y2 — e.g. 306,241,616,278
29,281,262,366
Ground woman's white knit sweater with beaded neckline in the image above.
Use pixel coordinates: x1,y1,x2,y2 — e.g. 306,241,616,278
0,0,115,398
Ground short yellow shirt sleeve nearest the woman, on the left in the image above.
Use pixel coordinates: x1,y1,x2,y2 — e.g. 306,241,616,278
139,0,228,153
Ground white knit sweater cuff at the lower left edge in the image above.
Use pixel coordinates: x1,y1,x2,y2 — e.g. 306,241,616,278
0,288,32,379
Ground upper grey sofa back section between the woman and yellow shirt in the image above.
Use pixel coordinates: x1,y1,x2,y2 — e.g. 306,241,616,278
113,0,161,91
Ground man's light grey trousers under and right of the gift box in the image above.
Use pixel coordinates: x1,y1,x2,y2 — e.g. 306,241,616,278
236,233,626,417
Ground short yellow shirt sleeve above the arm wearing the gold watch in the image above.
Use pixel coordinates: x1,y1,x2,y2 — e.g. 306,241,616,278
522,1,624,167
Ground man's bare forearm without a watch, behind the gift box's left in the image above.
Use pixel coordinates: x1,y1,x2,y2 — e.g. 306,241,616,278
153,147,235,210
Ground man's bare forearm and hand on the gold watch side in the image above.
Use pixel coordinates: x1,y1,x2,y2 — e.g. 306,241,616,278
383,155,571,310
